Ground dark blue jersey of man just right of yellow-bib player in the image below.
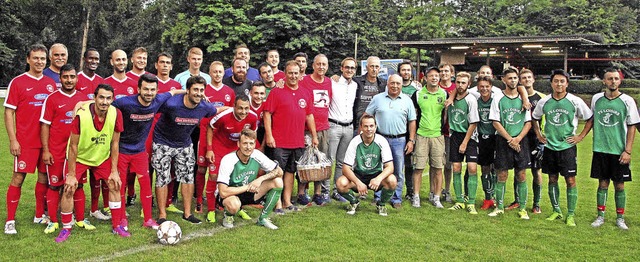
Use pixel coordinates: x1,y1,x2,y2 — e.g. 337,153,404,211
112,92,171,155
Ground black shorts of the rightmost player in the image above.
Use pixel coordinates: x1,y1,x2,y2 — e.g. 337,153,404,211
592,152,631,182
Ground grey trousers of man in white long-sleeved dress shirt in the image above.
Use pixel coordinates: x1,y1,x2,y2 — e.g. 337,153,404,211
322,122,353,193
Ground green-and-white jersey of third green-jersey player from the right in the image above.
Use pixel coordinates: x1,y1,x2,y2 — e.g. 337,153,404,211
489,93,531,137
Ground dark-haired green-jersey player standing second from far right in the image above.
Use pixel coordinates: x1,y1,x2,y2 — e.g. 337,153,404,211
532,69,593,226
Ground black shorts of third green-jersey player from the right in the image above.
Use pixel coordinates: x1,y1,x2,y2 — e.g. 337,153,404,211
493,136,531,170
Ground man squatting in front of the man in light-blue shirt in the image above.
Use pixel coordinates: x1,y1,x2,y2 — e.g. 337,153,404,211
336,115,398,216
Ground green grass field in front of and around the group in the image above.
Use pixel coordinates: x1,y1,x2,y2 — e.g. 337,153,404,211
0,97,640,261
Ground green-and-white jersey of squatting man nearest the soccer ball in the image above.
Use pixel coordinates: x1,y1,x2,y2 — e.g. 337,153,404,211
218,150,278,187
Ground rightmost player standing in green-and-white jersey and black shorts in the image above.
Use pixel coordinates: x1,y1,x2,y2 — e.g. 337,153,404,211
585,68,640,230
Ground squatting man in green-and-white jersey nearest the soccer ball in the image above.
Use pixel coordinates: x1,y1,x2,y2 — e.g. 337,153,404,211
218,129,282,229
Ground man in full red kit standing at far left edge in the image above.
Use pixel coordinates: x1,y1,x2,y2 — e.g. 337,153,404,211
4,44,56,234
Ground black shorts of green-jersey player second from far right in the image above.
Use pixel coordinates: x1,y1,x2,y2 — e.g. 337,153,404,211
542,146,578,177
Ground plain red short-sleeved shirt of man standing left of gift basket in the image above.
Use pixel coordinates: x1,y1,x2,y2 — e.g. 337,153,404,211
264,86,313,149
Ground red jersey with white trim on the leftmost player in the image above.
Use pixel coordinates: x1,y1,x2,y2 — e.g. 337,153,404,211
4,73,56,149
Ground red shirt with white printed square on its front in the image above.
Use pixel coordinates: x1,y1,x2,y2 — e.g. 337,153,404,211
299,75,332,131
